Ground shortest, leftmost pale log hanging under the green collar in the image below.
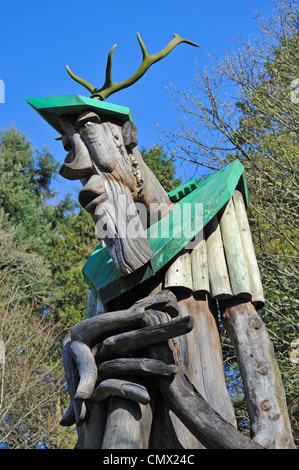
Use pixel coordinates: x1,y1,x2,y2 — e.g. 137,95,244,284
164,250,193,292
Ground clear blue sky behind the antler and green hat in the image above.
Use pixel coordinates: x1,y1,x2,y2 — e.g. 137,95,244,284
0,0,272,202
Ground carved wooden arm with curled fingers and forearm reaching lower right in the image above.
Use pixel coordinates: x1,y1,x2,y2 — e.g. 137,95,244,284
61,291,262,449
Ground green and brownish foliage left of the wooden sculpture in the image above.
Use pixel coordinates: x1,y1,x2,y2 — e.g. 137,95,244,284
0,128,93,448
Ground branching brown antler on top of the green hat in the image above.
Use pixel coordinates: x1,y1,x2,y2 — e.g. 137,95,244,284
66,33,199,101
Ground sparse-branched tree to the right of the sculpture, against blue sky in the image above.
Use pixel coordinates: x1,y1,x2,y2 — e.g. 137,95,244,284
163,0,299,443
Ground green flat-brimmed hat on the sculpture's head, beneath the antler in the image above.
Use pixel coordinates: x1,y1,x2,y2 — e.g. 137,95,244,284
26,95,133,135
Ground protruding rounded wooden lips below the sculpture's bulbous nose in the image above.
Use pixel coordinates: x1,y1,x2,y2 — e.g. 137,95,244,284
79,175,108,214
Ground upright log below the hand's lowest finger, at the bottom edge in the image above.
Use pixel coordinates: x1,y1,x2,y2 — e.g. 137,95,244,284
101,397,152,449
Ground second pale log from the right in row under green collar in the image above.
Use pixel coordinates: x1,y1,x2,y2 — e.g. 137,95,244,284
220,198,252,300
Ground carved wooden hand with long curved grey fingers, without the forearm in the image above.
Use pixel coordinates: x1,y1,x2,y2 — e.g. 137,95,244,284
61,291,192,426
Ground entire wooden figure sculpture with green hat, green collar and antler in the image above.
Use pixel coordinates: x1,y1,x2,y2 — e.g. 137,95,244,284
28,35,294,449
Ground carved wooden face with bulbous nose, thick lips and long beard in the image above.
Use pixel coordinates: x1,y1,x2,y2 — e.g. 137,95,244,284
60,112,170,275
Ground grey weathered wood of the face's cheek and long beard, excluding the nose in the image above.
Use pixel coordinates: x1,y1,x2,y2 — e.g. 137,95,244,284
79,116,152,276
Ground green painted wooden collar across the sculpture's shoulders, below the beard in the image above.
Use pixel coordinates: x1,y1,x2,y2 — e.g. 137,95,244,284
83,160,248,303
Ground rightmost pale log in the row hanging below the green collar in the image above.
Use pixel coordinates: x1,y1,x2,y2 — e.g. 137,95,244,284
233,191,265,309
